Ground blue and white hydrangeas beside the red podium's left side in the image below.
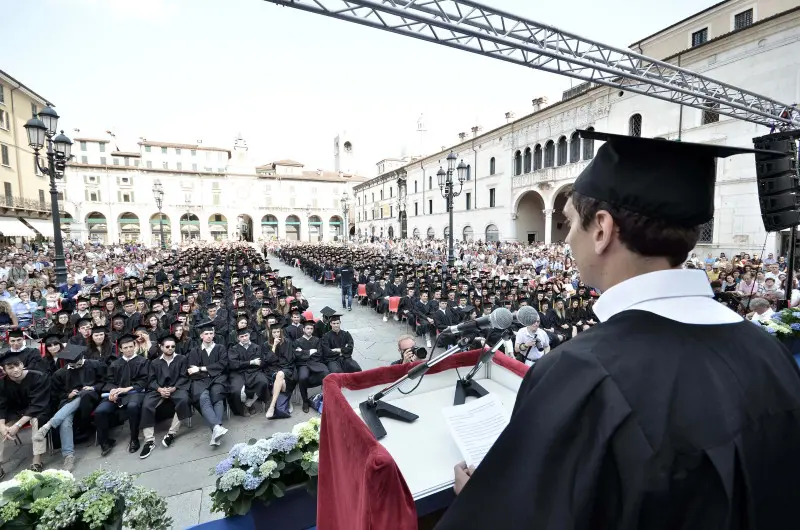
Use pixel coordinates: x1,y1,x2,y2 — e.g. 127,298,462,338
211,412,320,517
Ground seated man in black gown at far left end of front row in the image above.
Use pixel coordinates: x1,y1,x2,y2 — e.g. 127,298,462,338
0,352,50,480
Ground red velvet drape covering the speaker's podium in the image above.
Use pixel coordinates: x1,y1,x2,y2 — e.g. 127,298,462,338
317,350,528,530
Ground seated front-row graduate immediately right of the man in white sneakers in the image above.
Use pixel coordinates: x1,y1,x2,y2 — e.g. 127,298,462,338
228,328,269,416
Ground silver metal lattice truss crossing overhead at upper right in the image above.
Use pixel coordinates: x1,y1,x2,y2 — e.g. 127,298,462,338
265,0,800,130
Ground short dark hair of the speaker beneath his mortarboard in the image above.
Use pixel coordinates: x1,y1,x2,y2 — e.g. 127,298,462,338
570,191,700,267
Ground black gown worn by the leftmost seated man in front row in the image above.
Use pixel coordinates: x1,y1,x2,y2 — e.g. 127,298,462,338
0,370,50,426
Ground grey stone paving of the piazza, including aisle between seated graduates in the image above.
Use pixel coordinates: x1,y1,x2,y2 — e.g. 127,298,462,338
3,256,424,529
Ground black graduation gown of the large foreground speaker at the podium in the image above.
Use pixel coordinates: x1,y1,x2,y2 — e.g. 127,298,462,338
436,310,800,530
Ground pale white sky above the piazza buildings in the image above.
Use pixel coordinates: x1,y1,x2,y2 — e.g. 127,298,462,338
0,0,716,177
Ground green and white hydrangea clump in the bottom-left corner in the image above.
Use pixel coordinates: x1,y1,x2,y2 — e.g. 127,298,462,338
0,469,172,530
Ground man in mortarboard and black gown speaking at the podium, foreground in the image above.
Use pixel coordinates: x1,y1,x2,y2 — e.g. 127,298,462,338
437,132,800,530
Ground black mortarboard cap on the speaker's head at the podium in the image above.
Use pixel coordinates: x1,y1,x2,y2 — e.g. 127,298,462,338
573,130,771,227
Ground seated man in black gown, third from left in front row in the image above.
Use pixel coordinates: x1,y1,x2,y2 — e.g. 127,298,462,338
94,334,148,456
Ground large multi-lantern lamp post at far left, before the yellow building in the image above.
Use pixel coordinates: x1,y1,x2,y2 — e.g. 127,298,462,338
25,106,72,286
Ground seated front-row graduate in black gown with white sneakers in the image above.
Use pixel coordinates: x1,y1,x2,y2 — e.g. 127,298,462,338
188,322,231,446
